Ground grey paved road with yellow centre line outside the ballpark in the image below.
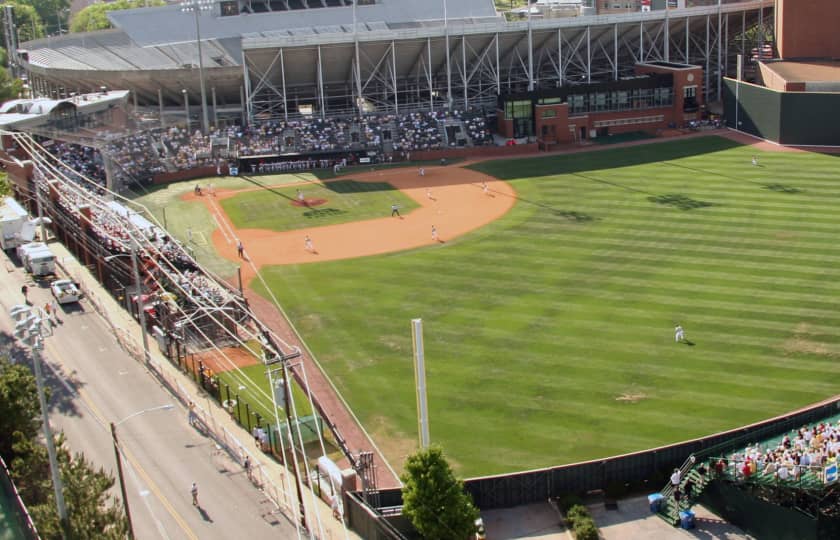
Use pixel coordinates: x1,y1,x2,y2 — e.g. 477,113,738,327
0,260,297,540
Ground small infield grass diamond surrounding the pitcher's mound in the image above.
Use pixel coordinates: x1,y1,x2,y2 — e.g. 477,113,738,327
221,180,419,231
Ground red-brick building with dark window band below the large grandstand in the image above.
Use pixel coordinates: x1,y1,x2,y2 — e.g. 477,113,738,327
497,62,705,145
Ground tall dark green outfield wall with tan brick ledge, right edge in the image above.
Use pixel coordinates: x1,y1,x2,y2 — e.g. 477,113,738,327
723,62,840,146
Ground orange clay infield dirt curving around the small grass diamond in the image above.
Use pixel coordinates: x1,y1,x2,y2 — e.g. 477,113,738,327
190,167,516,283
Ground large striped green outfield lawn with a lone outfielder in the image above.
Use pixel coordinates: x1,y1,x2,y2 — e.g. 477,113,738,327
253,137,840,476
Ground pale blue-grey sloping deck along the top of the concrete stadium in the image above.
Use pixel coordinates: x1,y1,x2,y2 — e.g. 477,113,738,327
108,0,498,46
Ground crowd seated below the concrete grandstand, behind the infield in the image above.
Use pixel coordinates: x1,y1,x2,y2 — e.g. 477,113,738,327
44,109,493,185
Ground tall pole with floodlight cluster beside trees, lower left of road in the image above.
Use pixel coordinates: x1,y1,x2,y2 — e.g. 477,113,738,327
9,305,67,538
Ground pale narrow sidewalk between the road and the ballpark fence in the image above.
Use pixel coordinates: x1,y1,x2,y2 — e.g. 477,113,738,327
49,241,360,539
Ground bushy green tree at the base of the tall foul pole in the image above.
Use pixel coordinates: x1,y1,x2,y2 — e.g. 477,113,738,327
401,447,479,540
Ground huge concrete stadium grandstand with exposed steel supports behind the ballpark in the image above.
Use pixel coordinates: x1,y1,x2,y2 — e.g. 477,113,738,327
16,0,774,125
